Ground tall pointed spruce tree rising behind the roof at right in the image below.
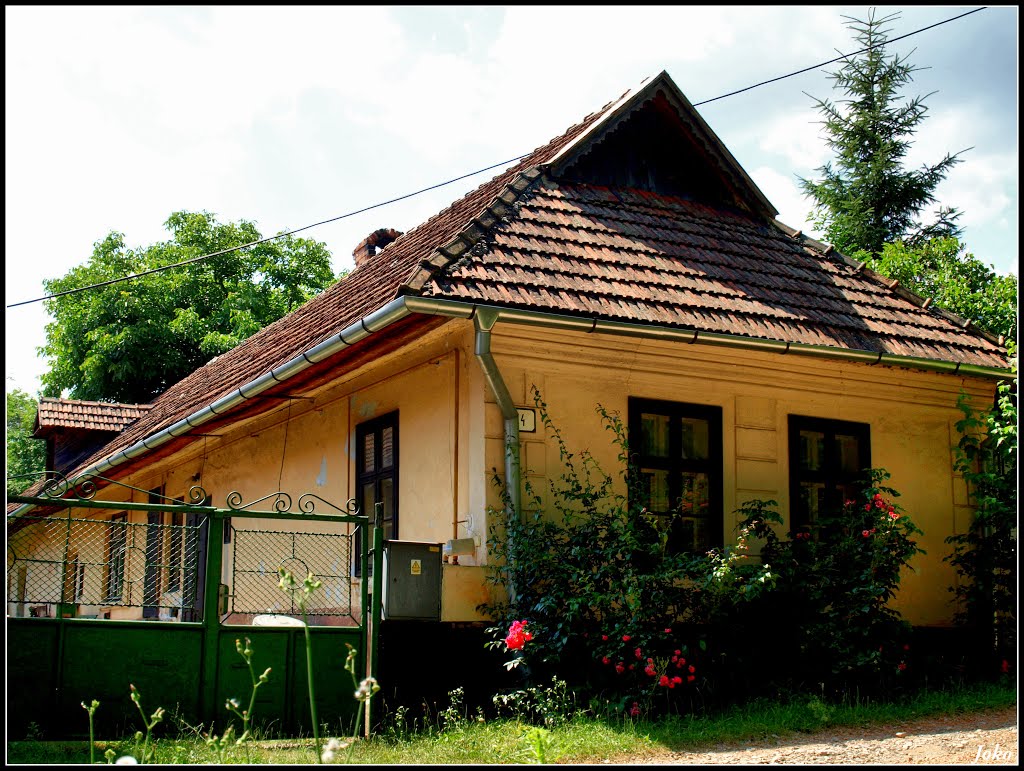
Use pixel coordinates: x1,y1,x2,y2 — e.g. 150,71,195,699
800,9,962,257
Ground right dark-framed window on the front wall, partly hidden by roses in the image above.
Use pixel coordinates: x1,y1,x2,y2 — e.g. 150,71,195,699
790,415,871,532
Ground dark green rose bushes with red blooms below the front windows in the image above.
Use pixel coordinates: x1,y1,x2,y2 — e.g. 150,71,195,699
488,388,921,717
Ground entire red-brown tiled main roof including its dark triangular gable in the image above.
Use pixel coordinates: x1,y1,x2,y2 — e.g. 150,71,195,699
22,73,1008,489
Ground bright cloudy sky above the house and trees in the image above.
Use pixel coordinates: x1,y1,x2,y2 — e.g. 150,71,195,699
4,5,1019,393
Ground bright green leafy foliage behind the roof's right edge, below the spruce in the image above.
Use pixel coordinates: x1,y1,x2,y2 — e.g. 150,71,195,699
871,237,1017,340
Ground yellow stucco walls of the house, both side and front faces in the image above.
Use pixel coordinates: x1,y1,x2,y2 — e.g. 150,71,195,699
24,320,994,625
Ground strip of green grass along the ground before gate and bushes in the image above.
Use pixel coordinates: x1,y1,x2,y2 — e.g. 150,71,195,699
7,682,1017,765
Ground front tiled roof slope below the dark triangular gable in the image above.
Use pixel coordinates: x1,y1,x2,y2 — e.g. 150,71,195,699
413,175,1007,368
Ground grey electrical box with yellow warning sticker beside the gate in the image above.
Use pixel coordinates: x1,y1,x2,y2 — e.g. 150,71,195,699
382,541,441,622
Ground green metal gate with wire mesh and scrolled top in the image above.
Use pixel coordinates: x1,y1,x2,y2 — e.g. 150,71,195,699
7,468,383,738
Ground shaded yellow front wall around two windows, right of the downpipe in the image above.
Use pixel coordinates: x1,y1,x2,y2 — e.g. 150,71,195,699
486,325,994,625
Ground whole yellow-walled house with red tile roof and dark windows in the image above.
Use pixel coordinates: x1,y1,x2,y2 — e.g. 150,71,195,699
8,73,1010,651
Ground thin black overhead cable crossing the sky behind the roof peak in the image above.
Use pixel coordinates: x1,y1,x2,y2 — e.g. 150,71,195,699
6,5,988,308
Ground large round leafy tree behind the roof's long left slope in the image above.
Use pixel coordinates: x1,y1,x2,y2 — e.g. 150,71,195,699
39,211,335,402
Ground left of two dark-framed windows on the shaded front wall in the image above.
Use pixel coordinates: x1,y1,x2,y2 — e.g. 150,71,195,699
629,397,723,554
